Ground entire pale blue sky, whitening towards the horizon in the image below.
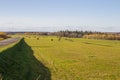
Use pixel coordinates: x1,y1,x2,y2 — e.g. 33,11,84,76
0,0,120,32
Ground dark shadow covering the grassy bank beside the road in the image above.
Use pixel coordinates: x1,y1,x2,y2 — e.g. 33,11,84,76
0,39,51,80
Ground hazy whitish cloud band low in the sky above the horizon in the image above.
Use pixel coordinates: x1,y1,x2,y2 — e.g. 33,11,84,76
0,17,120,31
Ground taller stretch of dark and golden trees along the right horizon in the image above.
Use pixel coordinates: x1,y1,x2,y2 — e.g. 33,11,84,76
51,31,120,40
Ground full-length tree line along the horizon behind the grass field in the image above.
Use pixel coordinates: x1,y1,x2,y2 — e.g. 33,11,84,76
7,30,120,40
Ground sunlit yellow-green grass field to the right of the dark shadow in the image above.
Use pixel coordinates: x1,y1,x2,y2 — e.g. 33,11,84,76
26,37,120,80
